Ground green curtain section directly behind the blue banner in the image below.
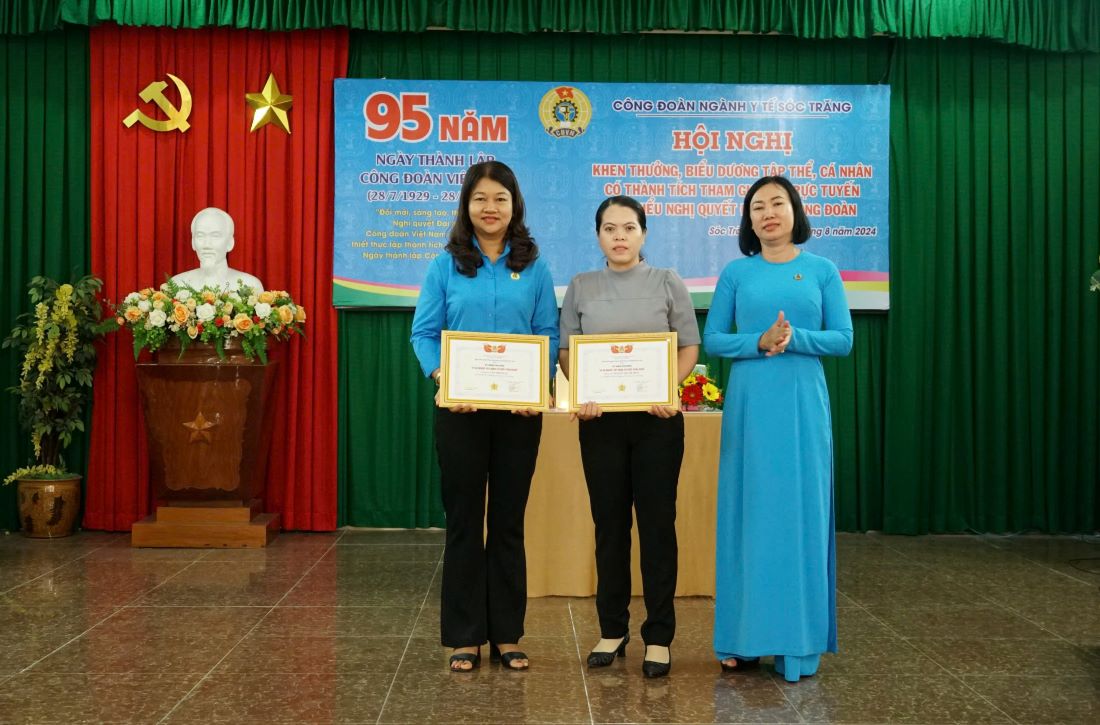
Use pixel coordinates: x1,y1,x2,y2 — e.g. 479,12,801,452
339,33,891,530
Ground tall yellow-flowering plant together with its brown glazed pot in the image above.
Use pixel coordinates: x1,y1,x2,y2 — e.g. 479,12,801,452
3,276,116,538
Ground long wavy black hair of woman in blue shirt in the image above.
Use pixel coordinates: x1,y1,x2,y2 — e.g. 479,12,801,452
447,161,539,277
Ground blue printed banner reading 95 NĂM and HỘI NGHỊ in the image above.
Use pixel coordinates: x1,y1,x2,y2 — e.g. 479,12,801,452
333,78,890,309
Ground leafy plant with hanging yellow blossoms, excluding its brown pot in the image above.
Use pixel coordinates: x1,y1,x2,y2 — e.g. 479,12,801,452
3,276,114,484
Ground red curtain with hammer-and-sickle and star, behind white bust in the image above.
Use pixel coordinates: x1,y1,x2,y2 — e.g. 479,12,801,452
84,24,348,530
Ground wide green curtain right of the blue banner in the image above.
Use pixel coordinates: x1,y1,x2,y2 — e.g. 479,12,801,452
883,41,1100,532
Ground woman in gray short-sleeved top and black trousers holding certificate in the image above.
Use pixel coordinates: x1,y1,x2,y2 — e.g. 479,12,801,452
559,196,700,677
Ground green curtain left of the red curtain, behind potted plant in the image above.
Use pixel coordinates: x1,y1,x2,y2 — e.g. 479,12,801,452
0,28,89,529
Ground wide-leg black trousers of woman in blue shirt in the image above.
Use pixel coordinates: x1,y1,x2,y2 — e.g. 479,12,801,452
436,408,542,647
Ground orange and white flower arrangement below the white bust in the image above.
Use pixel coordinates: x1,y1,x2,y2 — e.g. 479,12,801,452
116,279,306,364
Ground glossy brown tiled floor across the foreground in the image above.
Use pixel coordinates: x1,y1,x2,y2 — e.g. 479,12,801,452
0,530,1100,724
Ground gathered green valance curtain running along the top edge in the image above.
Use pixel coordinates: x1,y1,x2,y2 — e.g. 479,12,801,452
0,0,1100,52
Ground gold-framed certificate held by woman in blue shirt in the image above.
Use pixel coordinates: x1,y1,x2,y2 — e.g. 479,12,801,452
439,330,550,410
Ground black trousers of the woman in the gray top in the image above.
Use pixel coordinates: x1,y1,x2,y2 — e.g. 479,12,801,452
580,413,684,646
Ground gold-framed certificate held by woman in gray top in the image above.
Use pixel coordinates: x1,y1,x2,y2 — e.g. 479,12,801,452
569,332,680,411
